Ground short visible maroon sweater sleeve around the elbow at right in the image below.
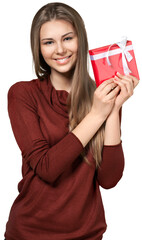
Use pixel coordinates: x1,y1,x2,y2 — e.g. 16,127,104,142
97,109,124,189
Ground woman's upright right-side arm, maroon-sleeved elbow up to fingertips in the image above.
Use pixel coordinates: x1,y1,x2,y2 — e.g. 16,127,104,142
97,73,139,189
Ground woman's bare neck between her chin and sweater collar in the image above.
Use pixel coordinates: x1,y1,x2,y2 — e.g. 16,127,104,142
50,70,73,93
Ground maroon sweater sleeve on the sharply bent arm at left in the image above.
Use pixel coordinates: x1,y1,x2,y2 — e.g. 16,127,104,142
8,82,83,183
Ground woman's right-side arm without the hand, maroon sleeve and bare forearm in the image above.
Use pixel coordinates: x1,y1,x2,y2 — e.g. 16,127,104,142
97,108,125,189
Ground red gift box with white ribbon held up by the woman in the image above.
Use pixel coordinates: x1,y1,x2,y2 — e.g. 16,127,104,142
89,38,140,87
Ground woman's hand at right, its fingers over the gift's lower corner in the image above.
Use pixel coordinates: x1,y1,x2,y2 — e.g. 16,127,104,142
111,73,139,110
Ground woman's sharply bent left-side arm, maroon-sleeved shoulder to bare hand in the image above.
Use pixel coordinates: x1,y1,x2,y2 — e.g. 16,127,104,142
8,80,116,183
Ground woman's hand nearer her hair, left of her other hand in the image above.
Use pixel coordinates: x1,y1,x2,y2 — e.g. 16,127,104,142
91,78,120,120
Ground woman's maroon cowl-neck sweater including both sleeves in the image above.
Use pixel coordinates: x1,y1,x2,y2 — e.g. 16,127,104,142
5,76,124,240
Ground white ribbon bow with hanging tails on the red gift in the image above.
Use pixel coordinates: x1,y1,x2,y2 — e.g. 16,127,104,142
106,37,133,75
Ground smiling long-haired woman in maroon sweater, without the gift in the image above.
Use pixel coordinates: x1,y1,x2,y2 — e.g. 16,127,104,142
5,3,138,240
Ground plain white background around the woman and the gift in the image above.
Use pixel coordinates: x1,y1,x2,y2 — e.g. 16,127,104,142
0,0,142,240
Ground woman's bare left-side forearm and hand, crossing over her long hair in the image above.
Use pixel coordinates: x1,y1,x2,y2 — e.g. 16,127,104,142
73,79,120,147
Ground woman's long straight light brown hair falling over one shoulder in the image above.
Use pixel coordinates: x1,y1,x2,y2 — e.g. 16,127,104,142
31,2,105,167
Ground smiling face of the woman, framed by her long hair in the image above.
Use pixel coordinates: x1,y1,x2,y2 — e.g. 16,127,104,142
40,20,78,73
